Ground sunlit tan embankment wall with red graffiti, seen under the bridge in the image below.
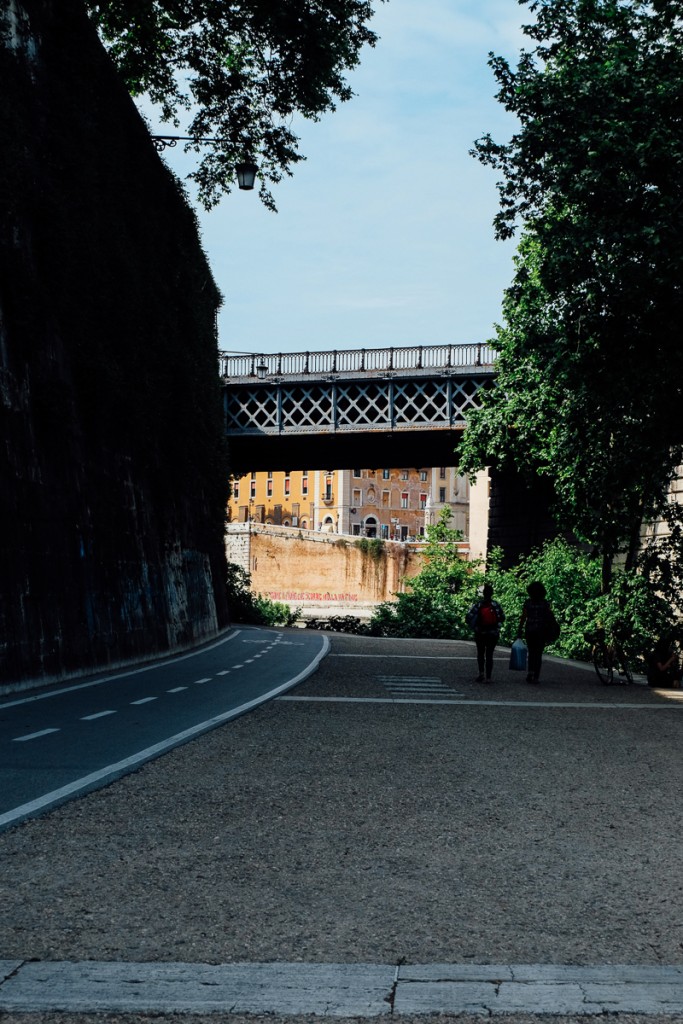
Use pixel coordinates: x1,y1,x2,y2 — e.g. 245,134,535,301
226,523,467,620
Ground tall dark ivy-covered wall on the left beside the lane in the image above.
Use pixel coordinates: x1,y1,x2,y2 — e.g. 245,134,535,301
0,0,228,684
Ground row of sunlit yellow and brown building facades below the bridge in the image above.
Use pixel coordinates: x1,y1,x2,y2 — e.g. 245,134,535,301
228,467,471,541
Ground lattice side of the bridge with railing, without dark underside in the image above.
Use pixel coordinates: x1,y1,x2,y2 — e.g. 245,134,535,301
222,345,494,436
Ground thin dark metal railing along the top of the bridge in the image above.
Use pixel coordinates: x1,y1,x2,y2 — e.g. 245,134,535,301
219,343,496,380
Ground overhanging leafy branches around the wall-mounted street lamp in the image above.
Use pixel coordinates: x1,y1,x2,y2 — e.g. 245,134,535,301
85,0,377,209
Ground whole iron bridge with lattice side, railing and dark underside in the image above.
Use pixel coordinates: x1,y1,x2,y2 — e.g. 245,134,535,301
220,344,495,469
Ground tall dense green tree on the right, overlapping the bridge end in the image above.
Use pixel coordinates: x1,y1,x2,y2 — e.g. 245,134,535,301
461,0,683,588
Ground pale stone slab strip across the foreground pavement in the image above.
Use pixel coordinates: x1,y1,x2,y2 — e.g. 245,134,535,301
0,961,683,1017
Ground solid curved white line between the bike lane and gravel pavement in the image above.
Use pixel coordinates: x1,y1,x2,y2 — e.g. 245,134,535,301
0,637,330,829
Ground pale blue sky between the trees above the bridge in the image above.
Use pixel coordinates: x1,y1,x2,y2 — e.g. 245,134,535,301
160,0,528,353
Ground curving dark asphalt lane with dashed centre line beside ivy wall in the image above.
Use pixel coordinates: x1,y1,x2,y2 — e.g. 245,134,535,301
0,628,328,830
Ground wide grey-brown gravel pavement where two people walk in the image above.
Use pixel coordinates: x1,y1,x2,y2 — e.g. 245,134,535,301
0,635,683,1024
